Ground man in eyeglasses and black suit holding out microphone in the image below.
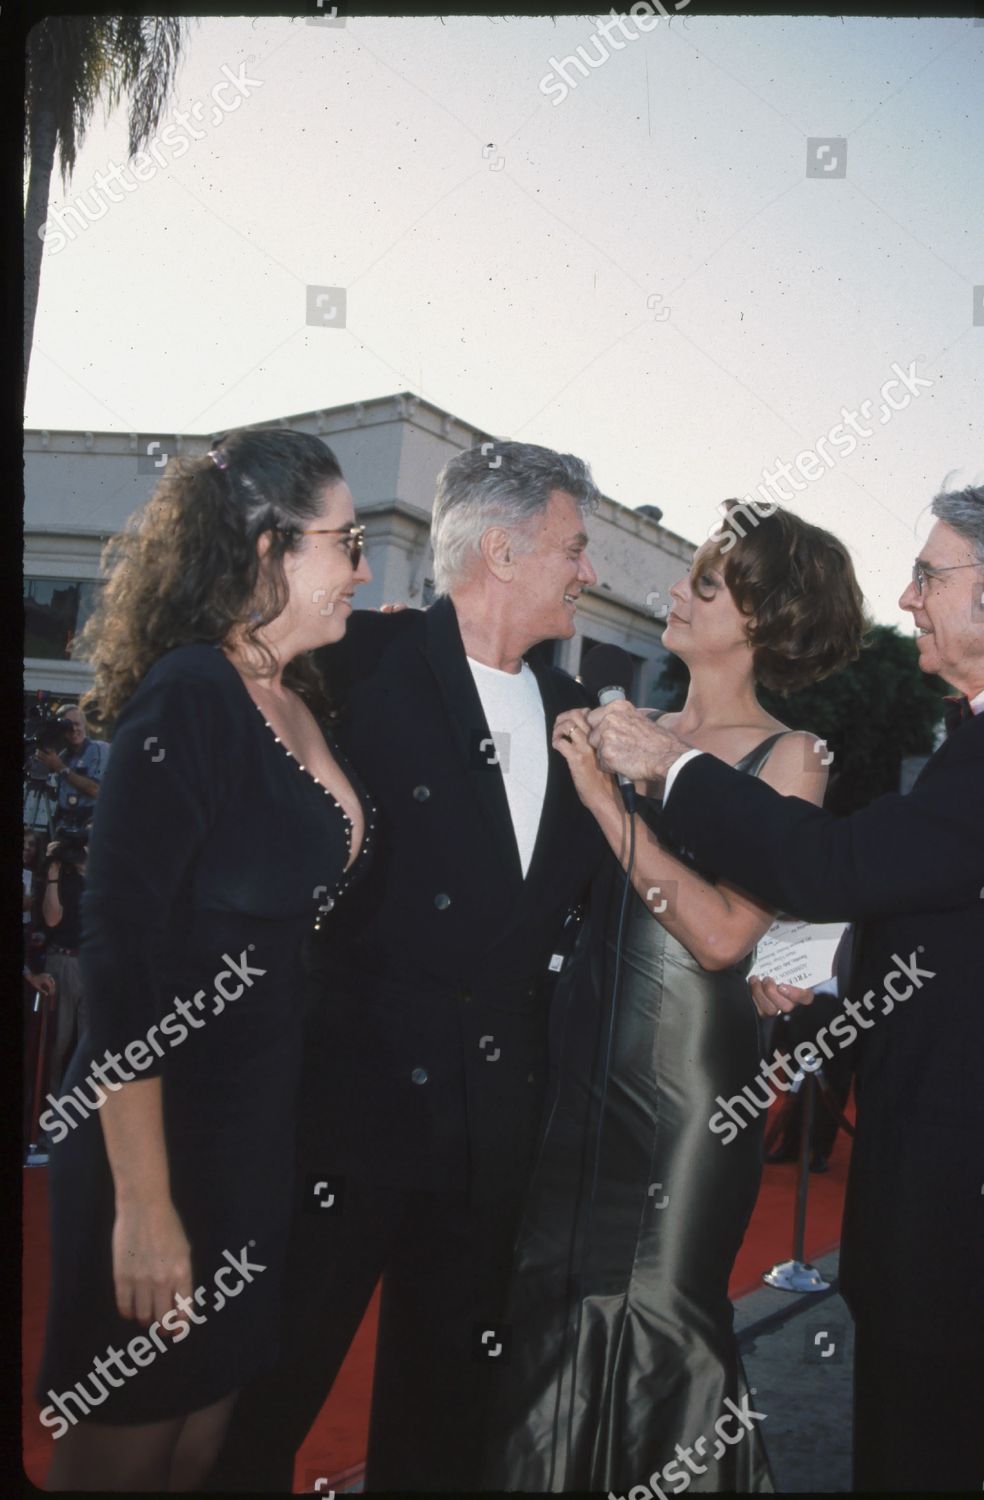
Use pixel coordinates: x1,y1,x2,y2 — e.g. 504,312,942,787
576,486,984,1493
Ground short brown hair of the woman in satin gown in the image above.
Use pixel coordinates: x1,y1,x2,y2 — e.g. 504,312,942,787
690,500,869,695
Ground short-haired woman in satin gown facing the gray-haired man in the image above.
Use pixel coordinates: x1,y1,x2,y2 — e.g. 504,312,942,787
488,501,864,1496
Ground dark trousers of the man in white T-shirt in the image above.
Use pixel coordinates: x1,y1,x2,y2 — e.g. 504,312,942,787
210,1181,525,1493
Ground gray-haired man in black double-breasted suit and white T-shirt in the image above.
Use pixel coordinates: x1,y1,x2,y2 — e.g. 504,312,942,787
215,443,603,1491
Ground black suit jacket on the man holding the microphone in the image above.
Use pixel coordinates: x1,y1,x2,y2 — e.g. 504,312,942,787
663,716,984,1356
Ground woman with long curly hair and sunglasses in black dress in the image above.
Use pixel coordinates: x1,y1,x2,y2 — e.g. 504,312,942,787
38,431,372,1491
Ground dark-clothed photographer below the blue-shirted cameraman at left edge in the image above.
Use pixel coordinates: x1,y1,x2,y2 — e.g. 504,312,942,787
41,831,89,1092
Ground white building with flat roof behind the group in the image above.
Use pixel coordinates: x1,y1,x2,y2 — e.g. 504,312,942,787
24,393,693,705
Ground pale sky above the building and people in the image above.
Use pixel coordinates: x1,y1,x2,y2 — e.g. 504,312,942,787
26,5,984,629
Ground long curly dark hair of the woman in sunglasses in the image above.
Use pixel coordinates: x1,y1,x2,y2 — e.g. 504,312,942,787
74,428,342,731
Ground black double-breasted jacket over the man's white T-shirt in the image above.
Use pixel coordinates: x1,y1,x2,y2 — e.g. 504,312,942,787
308,599,605,1197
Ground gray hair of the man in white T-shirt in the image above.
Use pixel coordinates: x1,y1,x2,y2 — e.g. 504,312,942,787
431,443,600,594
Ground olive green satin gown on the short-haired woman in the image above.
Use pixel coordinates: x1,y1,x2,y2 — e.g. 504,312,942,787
486,735,779,1500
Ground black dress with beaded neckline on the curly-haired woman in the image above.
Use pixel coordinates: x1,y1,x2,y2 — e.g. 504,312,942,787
38,645,374,1436
